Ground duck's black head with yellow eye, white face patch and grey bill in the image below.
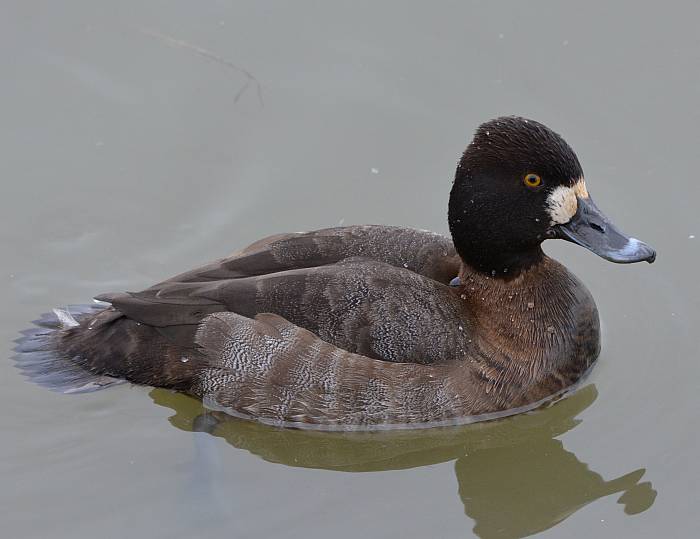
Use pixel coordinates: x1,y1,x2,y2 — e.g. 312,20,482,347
449,117,656,275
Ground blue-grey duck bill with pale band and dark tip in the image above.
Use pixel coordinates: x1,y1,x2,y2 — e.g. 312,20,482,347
554,197,656,264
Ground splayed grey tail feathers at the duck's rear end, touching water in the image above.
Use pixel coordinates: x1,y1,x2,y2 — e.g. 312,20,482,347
13,303,124,393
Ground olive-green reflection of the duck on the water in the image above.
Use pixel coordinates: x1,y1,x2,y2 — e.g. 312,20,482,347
150,385,656,538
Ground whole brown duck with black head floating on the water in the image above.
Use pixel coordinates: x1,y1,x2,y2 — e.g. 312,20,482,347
15,116,656,430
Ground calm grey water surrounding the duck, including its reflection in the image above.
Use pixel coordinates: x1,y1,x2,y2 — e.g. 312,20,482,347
0,0,700,539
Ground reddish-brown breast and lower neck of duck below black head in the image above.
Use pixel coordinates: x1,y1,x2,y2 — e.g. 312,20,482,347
459,254,599,379
